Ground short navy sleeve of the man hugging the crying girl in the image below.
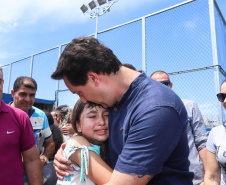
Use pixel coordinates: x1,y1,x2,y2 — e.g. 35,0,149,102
115,107,187,175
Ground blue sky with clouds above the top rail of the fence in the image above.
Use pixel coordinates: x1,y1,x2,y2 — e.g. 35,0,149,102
0,0,226,66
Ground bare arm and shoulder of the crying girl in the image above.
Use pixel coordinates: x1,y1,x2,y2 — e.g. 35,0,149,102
70,136,113,185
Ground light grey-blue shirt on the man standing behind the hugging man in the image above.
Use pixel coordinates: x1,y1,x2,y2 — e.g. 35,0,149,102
182,99,207,185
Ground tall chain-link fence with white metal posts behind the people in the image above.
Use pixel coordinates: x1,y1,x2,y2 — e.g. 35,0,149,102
0,0,226,127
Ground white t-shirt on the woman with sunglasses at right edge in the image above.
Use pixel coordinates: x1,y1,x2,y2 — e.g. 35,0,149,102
206,125,226,185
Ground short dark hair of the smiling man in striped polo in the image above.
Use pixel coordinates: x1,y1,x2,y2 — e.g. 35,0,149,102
13,76,37,92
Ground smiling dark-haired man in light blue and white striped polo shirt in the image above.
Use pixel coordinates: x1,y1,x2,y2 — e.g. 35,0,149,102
10,76,55,184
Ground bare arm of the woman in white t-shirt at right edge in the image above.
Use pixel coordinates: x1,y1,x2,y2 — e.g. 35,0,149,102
204,150,221,185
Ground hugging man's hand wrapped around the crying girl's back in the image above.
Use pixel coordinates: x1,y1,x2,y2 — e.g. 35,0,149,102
53,143,74,180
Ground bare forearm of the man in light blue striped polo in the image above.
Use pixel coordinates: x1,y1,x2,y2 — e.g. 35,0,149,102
40,137,55,166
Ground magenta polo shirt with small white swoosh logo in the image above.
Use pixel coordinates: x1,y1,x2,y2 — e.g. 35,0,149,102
0,100,35,185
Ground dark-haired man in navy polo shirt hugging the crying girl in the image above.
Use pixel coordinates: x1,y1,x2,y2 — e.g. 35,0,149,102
52,37,193,185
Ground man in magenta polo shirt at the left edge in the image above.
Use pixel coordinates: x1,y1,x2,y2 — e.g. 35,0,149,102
0,68,43,185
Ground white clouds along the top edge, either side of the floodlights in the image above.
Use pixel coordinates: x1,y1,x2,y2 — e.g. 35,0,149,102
0,0,160,32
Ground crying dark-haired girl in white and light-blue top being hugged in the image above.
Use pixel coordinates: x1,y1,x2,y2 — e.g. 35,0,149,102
57,99,112,185
